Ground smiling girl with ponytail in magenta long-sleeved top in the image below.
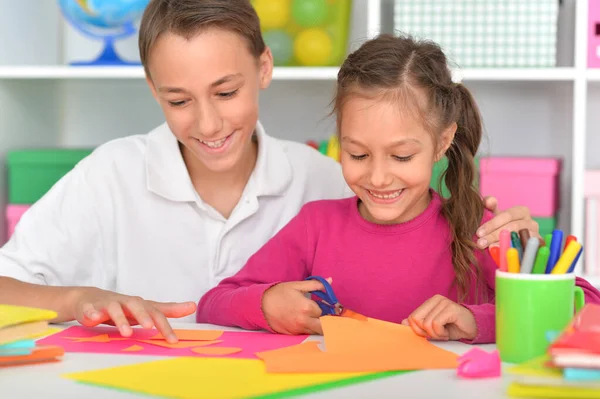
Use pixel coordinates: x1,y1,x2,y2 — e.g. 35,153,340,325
197,35,600,343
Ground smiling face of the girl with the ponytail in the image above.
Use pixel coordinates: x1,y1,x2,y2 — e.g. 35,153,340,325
340,96,455,224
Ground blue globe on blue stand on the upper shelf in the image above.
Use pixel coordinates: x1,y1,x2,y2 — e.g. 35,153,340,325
58,0,150,65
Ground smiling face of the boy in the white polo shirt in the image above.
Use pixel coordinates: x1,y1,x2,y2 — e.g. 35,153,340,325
148,28,273,172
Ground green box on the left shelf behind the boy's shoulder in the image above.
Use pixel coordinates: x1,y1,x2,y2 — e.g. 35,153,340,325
7,149,92,205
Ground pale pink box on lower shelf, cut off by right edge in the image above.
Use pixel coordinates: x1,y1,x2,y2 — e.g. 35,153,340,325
583,170,600,276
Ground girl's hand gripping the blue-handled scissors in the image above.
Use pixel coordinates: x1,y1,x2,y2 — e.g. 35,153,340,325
262,280,324,335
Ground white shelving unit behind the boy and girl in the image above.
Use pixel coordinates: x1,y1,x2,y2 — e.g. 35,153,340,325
0,0,600,287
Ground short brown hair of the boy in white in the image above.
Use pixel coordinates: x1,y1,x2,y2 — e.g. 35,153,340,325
138,0,265,77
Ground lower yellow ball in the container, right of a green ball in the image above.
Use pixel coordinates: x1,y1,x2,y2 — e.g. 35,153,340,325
294,28,333,66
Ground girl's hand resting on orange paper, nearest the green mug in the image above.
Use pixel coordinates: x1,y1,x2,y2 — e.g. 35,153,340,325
402,295,477,341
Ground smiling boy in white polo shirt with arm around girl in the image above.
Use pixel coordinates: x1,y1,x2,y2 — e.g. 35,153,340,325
0,0,537,340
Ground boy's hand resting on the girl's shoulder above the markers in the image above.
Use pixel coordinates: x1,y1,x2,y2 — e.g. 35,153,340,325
477,197,541,249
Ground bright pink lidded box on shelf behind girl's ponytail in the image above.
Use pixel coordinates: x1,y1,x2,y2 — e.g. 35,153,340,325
479,157,561,218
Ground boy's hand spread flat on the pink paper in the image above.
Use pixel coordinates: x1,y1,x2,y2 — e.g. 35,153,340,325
75,287,196,343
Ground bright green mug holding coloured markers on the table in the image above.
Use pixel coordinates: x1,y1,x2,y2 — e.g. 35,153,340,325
496,270,585,363
